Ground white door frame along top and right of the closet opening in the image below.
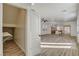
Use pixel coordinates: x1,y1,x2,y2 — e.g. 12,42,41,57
2,3,29,56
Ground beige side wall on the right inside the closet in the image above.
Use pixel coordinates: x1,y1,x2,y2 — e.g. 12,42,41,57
14,9,27,52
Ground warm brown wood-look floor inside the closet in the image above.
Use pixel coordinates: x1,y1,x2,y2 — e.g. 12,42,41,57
3,40,25,56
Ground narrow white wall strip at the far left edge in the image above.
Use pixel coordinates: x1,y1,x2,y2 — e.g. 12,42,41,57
0,3,3,56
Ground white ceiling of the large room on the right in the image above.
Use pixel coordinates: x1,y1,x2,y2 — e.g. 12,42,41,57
32,3,77,21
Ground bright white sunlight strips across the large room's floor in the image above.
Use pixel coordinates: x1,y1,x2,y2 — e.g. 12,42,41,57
41,42,72,48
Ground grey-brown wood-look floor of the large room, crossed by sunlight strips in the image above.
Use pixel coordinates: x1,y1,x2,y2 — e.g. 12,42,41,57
39,35,78,56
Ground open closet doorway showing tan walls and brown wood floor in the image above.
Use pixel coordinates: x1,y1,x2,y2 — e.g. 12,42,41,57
3,3,27,56
